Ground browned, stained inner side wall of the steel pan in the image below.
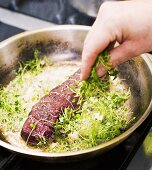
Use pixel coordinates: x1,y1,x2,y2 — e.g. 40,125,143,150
0,26,152,158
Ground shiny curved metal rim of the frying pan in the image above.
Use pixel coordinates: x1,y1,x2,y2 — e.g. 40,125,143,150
0,25,152,159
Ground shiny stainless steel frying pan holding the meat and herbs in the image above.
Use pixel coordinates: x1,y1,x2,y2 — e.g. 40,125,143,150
0,25,152,162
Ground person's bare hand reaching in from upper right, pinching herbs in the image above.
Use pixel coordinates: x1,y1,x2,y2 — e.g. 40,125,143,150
81,0,152,80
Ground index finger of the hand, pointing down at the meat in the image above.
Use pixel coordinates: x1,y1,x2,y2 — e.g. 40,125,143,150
81,20,113,80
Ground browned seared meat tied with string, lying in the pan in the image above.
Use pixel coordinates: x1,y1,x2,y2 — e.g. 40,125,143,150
21,70,80,145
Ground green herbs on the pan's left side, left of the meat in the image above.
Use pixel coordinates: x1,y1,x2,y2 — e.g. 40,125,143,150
0,50,48,132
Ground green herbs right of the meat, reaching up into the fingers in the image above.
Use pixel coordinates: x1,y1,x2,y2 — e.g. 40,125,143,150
53,51,130,152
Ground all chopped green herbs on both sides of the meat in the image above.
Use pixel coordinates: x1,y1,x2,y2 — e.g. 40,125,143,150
0,50,131,152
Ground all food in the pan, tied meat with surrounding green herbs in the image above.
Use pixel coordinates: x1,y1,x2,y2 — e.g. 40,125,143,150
0,51,132,152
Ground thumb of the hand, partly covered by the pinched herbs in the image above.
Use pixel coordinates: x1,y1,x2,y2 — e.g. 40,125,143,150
97,41,139,77
